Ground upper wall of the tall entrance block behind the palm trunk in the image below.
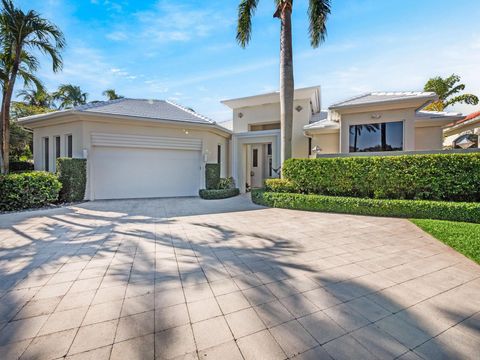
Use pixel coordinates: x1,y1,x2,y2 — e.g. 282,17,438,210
233,99,311,158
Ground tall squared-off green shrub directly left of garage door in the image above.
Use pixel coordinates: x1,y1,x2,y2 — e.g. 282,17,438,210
57,158,87,202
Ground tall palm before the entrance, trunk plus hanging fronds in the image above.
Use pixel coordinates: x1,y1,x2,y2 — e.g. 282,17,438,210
237,0,330,164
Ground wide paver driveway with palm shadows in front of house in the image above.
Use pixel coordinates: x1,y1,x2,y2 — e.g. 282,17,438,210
0,196,480,360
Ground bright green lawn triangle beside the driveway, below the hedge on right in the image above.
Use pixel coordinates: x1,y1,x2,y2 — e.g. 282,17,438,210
411,219,480,264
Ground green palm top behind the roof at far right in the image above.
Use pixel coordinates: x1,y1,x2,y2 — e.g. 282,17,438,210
424,74,478,111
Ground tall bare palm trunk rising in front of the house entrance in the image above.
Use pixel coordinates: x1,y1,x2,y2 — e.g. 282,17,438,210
280,5,294,170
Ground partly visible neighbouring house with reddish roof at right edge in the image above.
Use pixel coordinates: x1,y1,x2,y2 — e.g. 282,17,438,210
443,111,480,148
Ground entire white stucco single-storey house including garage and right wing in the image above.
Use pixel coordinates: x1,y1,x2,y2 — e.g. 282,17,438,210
20,86,463,200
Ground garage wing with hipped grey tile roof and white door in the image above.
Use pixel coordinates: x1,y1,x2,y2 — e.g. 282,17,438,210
20,99,231,200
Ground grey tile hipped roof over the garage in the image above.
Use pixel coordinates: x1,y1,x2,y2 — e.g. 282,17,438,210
72,98,215,124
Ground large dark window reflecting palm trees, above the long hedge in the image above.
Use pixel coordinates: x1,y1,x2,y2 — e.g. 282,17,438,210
349,121,403,152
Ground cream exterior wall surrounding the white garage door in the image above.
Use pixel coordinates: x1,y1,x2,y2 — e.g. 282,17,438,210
32,117,231,199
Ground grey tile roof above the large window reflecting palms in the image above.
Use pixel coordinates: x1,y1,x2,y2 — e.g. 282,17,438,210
330,91,436,109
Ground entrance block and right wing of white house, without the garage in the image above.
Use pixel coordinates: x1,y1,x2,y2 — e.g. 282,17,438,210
223,87,463,191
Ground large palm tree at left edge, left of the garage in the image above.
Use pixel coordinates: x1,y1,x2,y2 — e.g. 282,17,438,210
0,0,65,173
